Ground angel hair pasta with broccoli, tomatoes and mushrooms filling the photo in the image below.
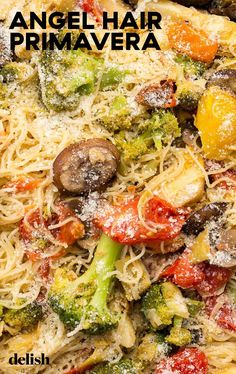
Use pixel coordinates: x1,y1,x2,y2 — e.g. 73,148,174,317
0,0,236,374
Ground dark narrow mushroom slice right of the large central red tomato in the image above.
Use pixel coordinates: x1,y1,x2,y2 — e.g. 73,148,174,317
183,202,227,235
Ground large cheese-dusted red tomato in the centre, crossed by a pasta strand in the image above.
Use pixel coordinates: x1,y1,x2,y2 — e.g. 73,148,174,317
95,196,189,244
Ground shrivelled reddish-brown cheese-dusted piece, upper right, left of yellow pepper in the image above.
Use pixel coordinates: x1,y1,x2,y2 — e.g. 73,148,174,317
136,79,176,108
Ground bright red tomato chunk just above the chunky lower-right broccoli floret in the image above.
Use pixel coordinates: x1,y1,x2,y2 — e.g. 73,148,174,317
161,254,205,288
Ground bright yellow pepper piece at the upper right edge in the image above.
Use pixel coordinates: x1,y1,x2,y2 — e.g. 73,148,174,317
195,86,236,160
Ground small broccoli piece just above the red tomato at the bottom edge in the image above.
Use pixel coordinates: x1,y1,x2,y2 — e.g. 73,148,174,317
165,317,192,347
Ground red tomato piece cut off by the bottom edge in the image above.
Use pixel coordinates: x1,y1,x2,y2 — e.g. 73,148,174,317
155,348,208,374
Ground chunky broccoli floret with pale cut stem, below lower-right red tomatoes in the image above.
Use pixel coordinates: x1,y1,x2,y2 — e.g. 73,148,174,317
142,282,189,330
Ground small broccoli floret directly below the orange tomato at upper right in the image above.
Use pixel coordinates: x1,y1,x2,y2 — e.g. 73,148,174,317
174,54,207,79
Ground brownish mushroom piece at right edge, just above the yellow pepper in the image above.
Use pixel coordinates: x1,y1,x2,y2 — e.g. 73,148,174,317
207,69,236,96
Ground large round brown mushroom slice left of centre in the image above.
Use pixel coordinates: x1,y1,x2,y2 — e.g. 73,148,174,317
53,139,119,194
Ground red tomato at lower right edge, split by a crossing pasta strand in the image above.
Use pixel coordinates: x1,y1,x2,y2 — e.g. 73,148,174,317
205,297,236,332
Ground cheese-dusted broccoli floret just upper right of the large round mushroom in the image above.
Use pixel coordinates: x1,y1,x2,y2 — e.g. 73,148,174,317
115,110,181,162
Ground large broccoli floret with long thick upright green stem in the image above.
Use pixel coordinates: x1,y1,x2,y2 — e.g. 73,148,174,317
49,234,123,334
